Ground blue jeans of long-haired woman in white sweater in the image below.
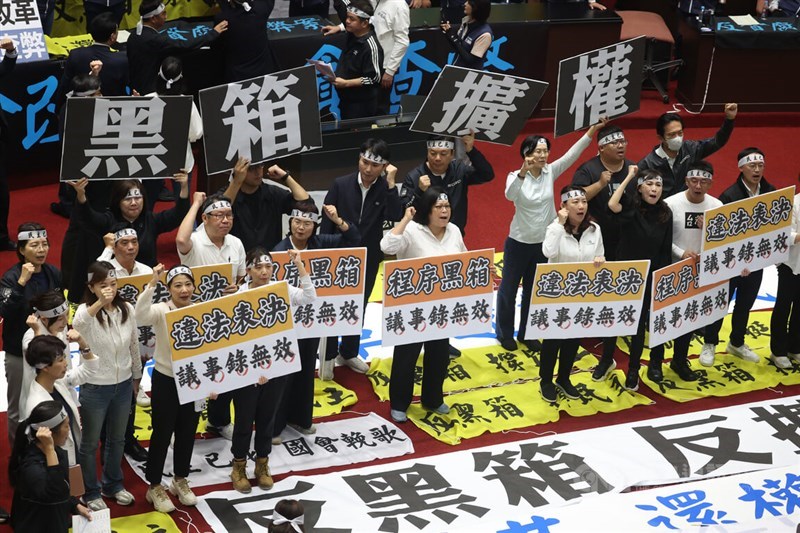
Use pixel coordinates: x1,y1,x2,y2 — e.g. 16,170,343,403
78,378,133,501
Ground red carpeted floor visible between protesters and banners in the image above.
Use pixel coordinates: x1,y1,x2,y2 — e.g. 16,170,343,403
0,89,800,531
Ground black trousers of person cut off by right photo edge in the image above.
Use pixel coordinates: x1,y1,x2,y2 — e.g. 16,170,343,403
769,264,800,356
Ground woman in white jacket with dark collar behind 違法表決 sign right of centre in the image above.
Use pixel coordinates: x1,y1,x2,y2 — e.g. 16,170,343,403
540,185,605,403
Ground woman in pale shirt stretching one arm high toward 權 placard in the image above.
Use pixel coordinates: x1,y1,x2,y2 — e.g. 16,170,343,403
495,118,608,351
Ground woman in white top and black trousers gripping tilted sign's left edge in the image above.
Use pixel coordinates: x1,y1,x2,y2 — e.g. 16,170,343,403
136,264,203,513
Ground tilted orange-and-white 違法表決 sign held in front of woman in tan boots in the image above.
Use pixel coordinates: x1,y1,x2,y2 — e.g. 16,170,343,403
166,282,300,404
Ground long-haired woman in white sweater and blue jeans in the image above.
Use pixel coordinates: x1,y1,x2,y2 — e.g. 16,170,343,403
72,261,142,511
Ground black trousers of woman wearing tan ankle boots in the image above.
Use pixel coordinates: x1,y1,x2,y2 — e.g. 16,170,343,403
231,376,287,459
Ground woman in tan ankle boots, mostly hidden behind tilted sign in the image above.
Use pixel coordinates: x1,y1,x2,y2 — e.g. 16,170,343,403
231,247,317,494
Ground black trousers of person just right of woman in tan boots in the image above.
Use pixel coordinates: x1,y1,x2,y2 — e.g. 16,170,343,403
276,339,319,436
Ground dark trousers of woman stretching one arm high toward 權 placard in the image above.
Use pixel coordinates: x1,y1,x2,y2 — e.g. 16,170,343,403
496,237,547,341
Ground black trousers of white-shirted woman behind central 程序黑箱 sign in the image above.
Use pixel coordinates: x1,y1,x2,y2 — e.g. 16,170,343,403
389,339,450,412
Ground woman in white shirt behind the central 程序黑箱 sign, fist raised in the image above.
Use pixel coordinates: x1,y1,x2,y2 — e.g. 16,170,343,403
381,187,467,422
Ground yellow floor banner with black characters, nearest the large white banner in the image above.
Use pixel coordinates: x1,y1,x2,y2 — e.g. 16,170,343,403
408,371,652,445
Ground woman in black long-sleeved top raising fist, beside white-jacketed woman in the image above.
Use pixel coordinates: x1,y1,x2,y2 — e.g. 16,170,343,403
600,165,691,391
